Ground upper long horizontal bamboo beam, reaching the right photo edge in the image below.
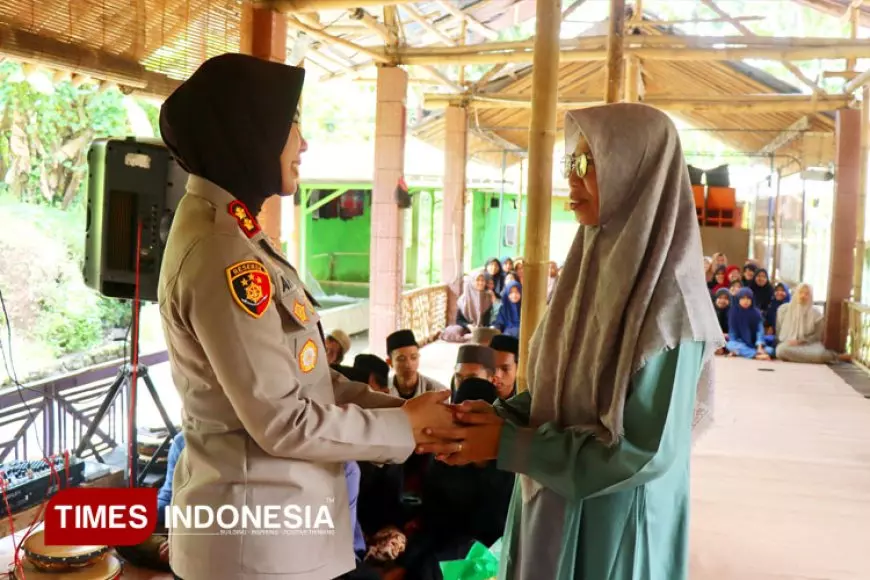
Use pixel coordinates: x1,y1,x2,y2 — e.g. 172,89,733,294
392,42,870,65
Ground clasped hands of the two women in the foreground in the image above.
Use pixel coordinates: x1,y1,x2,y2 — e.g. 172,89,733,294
402,390,504,465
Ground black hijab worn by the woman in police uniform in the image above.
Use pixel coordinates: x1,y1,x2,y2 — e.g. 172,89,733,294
160,53,305,215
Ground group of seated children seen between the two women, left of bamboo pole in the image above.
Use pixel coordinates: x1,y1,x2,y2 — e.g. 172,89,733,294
441,258,559,342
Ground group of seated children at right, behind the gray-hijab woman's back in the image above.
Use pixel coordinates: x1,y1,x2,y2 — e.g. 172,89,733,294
704,254,849,364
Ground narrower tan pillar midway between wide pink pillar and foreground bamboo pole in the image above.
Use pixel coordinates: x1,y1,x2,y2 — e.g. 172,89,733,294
441,106,468,284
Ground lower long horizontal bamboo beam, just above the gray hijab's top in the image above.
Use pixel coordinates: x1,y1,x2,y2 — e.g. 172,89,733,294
423,93,851,113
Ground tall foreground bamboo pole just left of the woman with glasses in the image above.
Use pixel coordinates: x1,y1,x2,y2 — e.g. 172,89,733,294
517,0,562,391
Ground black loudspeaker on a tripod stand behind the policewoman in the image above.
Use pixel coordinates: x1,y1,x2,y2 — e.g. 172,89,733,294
82,137,187,302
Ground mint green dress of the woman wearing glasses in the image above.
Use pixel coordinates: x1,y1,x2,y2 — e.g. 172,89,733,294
497,341,706,580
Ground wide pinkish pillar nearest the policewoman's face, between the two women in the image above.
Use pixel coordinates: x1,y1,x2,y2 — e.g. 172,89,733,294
369,66,408,355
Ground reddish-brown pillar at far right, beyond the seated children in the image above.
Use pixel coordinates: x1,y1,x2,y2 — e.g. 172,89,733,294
825,109,861,352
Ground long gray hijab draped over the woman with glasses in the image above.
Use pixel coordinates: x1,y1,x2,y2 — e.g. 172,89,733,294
528,103,722,445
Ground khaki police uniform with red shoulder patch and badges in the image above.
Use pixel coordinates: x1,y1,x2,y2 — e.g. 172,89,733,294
159,176,414,580
